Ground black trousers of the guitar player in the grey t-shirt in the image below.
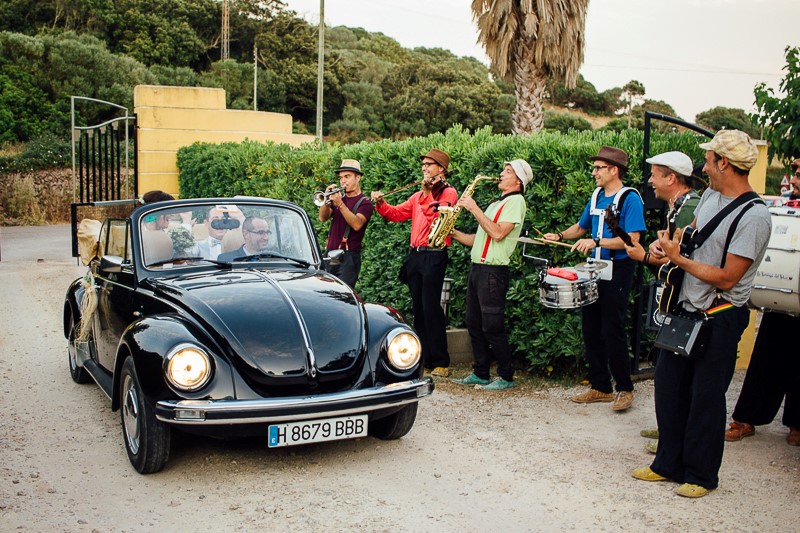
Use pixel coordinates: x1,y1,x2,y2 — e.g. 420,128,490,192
650,307,750,489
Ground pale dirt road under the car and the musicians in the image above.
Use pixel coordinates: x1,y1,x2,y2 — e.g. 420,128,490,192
0,226,800,532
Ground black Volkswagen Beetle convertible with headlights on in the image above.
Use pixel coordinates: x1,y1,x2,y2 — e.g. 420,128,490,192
64,197,434,474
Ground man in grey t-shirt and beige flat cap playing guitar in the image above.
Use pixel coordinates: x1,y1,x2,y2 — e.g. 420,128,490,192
633,130,771,498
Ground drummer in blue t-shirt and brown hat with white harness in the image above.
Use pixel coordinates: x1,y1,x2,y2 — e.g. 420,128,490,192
544,146,645,411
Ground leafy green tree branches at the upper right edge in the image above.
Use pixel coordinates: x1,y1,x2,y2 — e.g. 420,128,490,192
754,46,800,163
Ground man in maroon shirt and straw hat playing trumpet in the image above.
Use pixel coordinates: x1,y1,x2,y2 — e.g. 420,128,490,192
319,159,373,288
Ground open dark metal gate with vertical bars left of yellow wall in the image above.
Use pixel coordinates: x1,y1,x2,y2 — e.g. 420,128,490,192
70,96,138,257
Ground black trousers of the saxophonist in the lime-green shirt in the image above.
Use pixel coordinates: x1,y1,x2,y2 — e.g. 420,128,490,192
466,263,514,381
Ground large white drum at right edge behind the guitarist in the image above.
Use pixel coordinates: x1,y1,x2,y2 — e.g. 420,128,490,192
750,207,800,314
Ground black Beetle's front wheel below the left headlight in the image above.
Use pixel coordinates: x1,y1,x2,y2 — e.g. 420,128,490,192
120,356,170,474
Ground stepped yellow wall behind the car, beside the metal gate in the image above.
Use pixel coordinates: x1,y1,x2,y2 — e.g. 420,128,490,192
133,85,314,197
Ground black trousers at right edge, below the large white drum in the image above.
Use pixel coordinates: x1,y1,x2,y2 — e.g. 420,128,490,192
733,312,800,428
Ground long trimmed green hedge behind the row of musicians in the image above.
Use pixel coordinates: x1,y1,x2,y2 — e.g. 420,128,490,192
178,126,704,374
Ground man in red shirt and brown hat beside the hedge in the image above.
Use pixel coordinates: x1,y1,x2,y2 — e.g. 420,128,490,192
370,148,458,377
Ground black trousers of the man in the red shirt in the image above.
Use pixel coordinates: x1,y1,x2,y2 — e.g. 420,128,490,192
405,249,450,369
